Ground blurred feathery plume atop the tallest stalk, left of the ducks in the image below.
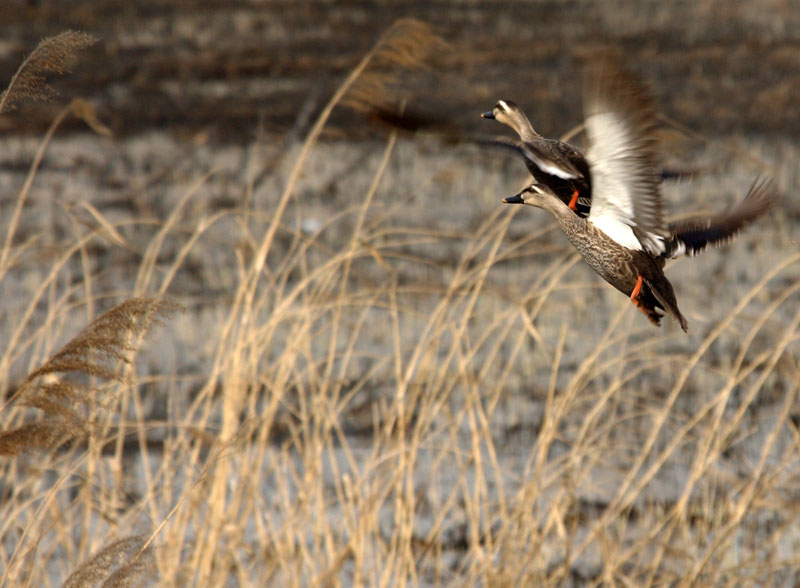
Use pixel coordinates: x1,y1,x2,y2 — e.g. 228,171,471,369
342,18,447,112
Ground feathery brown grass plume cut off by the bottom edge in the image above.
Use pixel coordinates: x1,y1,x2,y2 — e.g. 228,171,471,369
62,535,155,588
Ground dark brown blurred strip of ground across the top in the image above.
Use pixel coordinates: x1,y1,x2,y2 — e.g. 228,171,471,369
0,0,800,139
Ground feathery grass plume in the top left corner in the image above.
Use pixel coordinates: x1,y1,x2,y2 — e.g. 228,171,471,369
0,31,97,113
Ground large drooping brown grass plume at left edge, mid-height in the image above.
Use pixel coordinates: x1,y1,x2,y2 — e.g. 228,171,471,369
0,298,180,455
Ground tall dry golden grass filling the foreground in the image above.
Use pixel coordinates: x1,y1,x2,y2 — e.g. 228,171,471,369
0,23,800,586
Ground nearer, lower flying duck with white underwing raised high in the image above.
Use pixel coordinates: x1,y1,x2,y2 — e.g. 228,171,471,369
503,60,776,332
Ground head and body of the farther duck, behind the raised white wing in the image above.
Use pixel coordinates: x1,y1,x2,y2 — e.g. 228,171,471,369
481,100,592,218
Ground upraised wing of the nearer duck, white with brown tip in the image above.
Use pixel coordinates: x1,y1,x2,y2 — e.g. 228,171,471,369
584,61,667,255
